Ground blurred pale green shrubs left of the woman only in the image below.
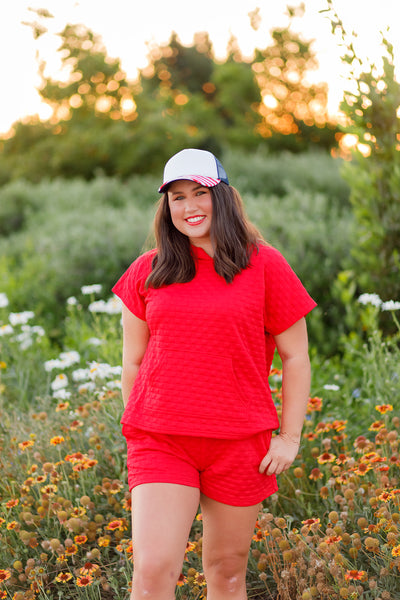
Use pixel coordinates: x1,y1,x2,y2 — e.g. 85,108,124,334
0,177,156,336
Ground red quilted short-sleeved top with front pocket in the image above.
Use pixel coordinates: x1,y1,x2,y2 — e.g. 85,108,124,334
113,245,316,438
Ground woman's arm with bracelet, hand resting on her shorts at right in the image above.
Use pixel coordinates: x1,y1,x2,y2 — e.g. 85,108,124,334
260,318,311,475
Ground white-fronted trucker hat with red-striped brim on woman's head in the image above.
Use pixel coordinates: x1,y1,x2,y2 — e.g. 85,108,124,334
158,148,229,193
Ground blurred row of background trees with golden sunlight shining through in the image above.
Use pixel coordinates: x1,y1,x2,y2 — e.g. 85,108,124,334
0,9,337,184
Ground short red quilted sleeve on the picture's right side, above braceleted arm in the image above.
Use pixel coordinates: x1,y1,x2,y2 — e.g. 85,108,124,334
264,247,317,335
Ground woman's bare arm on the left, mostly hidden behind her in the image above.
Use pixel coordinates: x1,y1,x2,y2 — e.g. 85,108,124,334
121,304,150,406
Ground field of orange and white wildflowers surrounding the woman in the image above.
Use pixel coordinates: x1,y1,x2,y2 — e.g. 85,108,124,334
0,285,400,600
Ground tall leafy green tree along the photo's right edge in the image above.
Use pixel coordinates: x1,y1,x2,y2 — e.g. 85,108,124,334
328,0,400,308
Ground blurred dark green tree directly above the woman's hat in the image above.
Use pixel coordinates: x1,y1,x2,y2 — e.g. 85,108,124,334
138,33,261,150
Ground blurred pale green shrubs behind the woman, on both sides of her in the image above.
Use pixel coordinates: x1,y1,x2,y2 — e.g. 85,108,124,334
0,150,352,353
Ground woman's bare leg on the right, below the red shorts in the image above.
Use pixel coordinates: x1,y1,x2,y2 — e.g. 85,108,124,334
200,495,260,600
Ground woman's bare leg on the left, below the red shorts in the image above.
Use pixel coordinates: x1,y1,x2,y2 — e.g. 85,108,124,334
131,483,200,600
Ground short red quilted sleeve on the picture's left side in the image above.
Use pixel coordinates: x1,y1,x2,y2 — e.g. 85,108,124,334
112,251,155,321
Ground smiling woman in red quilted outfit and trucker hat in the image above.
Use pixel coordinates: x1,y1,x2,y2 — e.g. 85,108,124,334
113,149,315,600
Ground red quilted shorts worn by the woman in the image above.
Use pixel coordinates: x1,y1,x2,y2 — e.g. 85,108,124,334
122,425,278,506
